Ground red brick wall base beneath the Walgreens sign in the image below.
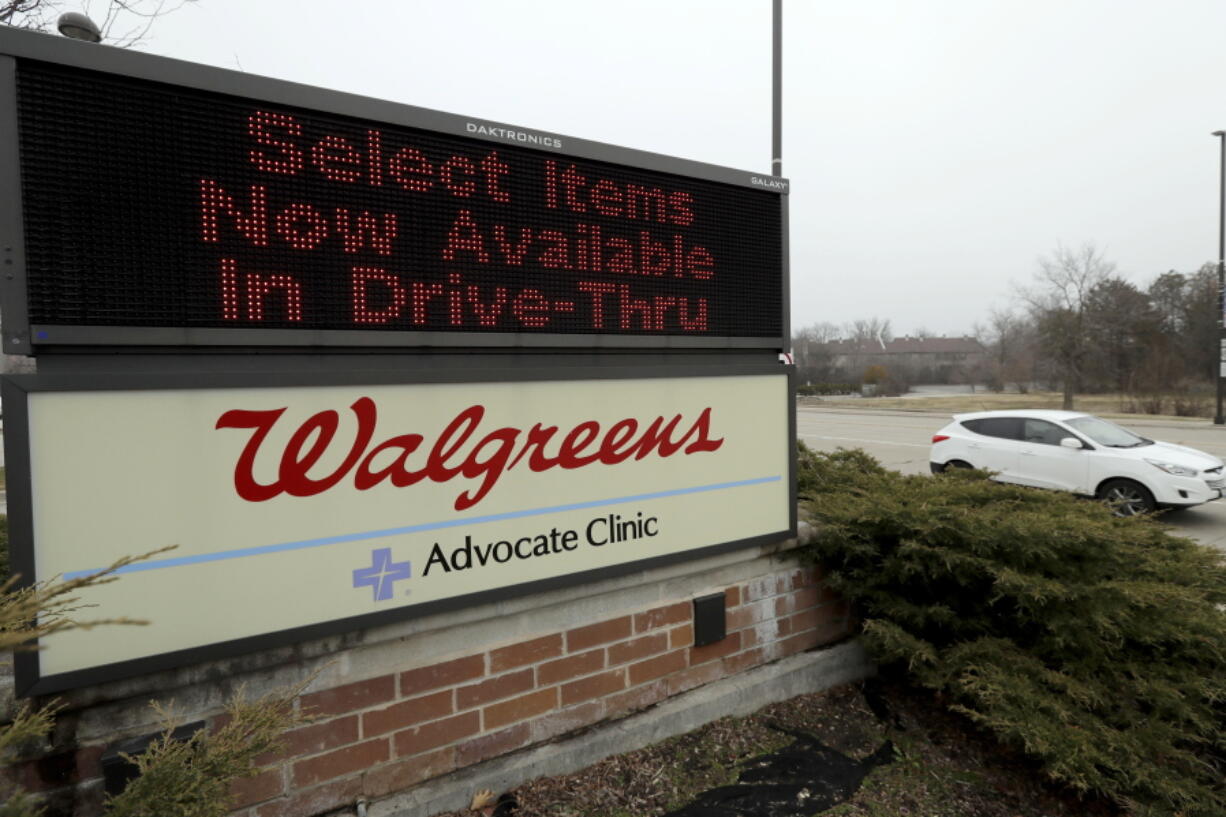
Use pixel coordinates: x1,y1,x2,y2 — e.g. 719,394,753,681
225,569,848,817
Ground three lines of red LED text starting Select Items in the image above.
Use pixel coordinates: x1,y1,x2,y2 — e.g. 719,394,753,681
196,110,720,334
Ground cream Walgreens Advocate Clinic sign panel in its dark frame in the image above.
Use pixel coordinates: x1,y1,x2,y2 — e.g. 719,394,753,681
5,367,794,691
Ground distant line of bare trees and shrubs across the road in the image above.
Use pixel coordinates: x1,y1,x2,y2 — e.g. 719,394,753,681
792,244,1219,413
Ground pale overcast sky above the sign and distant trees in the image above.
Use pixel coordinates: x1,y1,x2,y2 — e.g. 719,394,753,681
124,0,1226,335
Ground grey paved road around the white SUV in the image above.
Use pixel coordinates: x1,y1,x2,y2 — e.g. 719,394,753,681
796,405,1226,552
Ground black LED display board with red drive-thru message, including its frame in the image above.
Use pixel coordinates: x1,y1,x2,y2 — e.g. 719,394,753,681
0,32,787,353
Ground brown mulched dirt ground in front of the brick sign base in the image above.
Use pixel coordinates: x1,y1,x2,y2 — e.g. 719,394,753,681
444,681,1122,817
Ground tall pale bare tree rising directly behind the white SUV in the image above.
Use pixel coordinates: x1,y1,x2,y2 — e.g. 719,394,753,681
1019,243,1116,410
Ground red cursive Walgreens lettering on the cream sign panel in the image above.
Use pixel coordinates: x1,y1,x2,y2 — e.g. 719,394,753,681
216,397,723,510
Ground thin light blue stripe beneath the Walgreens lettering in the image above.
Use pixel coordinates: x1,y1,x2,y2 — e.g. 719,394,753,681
64,476,783,579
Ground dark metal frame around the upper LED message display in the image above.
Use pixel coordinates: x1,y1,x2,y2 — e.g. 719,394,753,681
0,28,791,355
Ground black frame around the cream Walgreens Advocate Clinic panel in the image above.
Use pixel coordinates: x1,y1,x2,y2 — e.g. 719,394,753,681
0,361,799,697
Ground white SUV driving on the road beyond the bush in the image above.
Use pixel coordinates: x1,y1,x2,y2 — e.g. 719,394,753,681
928,410,1226,516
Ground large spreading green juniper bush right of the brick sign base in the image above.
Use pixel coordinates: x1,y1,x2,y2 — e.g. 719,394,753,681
798,448,1226,817
